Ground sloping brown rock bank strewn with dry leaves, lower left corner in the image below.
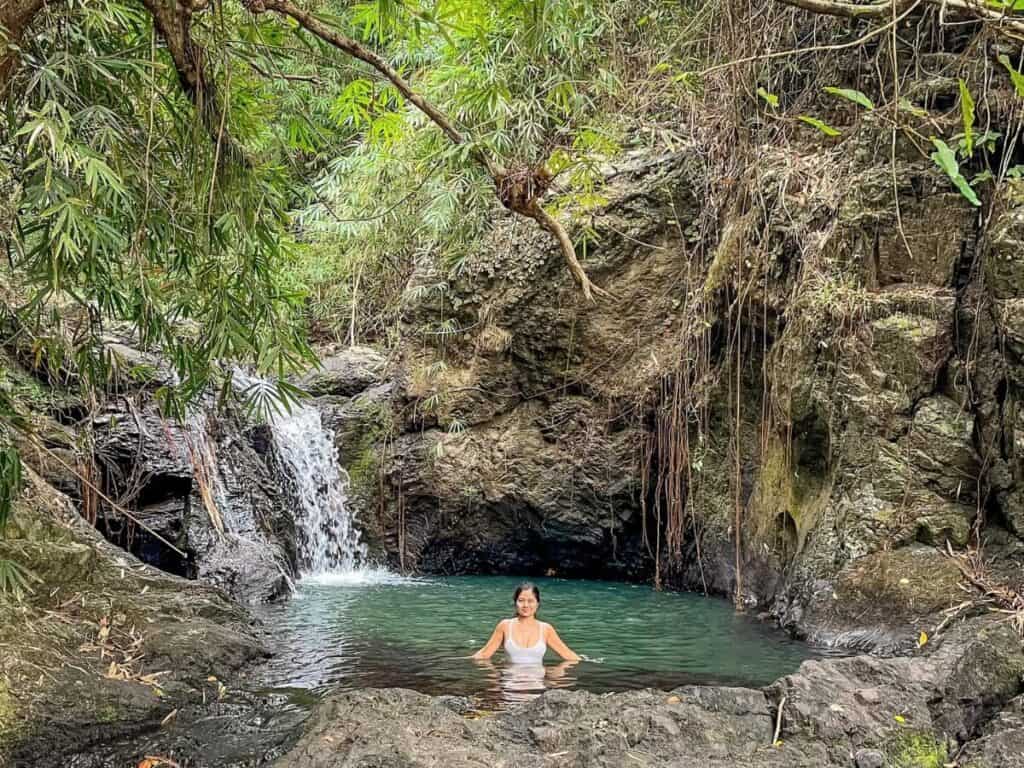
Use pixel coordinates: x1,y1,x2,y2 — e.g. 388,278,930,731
0,472,278,768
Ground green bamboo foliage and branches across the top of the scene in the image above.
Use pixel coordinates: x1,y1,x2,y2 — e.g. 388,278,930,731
0,0,1024,573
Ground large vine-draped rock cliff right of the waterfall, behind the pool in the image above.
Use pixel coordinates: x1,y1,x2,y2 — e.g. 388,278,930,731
337,145,1024,651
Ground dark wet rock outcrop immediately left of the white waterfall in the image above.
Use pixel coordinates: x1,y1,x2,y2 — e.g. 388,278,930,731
92,393,295,602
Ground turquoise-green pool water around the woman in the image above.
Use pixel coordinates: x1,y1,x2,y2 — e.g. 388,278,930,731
256,577,814,708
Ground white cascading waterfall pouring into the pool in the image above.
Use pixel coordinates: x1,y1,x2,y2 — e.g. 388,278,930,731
270,406,367,577
